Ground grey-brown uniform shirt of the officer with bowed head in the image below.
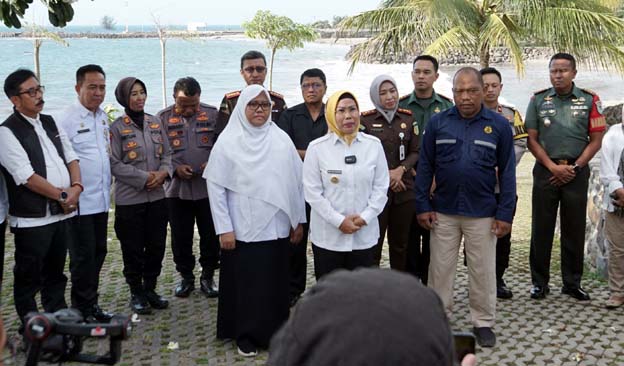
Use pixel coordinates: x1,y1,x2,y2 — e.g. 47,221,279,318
157,103,217,201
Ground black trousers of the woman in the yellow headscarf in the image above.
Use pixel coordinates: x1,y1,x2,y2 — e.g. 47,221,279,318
312,243,375,281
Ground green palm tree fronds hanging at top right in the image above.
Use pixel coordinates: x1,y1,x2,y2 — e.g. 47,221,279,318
340,0,624,75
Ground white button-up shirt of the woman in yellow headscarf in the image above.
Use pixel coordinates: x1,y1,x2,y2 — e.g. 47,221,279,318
303,133,390,252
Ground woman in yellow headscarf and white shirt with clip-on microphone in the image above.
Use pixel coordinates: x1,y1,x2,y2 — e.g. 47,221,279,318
303,91,390,280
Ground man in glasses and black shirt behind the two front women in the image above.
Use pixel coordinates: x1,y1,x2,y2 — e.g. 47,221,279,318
277,69,327,306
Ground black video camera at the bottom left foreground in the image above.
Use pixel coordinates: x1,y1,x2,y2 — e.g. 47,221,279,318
24,309,132,366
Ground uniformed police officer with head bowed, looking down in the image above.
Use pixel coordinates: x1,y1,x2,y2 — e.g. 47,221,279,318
157,77,219,297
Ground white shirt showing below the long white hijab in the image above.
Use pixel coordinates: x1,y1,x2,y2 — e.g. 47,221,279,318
207,181,306,243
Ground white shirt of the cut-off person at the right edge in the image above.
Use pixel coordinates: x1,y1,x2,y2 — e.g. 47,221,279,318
600,123,624,212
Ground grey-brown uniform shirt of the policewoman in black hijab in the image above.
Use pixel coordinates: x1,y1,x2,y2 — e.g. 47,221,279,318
110,113,171,205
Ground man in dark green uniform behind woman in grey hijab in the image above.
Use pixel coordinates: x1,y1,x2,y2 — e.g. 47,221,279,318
399,55,453,285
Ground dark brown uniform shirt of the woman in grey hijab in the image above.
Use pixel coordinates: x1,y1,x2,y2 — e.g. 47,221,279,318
360,108,420,204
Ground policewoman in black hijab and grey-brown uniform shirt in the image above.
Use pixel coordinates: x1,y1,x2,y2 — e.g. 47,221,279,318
110,77,171,314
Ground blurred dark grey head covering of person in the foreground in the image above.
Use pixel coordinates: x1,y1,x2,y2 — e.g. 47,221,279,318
268,269,455,366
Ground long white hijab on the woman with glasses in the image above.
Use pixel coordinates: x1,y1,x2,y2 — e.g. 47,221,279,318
203,85,303,228
